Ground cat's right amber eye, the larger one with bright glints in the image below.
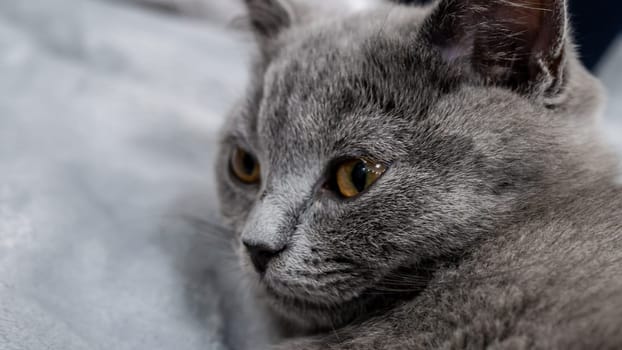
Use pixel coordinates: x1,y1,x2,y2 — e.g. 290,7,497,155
335,158,387,198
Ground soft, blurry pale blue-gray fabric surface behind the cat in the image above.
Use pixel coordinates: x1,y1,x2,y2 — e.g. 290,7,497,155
0,0,622,350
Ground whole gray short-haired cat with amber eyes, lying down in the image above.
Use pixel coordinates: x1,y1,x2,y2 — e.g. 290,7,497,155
218,0,622,349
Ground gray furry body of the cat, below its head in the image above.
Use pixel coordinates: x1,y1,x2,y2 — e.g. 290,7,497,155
284,188,622,350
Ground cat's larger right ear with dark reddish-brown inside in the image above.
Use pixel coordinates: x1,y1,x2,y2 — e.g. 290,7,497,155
422,0,568,97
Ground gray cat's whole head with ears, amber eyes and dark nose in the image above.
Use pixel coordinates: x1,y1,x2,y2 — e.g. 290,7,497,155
218,0,601,328
